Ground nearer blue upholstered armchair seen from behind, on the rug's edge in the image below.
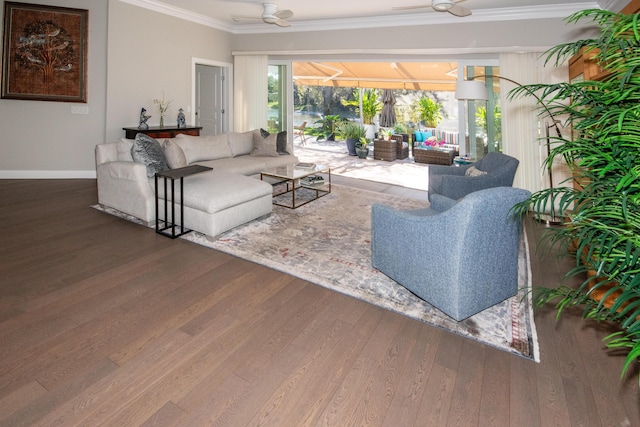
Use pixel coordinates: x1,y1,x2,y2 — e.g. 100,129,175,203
371,187,531,321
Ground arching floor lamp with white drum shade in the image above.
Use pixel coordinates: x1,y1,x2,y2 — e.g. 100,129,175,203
455,74,562,225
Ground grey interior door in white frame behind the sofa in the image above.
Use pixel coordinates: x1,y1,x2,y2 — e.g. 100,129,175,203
195,64,227,135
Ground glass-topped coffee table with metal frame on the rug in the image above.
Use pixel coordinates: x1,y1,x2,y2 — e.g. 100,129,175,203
260,165,331,209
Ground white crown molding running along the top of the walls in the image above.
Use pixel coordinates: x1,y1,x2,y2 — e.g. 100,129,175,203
119,0,600,34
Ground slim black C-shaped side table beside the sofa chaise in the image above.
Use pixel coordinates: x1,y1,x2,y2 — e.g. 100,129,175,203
155,165,213,239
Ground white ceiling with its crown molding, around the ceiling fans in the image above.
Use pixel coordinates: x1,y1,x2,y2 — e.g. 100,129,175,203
121,0,628,33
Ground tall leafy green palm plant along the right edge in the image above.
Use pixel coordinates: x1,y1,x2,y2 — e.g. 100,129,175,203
509,9,640,380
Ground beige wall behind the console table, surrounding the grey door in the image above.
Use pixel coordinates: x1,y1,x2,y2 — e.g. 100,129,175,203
106,0,233,141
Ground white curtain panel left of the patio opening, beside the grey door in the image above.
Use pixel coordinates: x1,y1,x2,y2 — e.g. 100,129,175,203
233,55,269,132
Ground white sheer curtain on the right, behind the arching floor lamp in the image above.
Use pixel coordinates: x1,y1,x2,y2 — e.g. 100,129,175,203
500,53,546,192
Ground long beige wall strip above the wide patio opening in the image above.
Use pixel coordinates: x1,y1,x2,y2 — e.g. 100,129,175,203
233,18,586,57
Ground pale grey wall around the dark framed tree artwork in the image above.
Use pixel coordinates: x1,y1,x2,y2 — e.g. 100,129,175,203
0,0,107,178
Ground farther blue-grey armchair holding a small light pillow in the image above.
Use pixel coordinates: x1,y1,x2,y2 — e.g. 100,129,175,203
428,152,520,201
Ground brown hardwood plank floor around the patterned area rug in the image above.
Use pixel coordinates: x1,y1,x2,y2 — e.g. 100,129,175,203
0,178,640,427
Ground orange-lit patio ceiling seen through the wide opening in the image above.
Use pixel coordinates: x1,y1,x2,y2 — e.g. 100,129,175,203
293,62,457,91
